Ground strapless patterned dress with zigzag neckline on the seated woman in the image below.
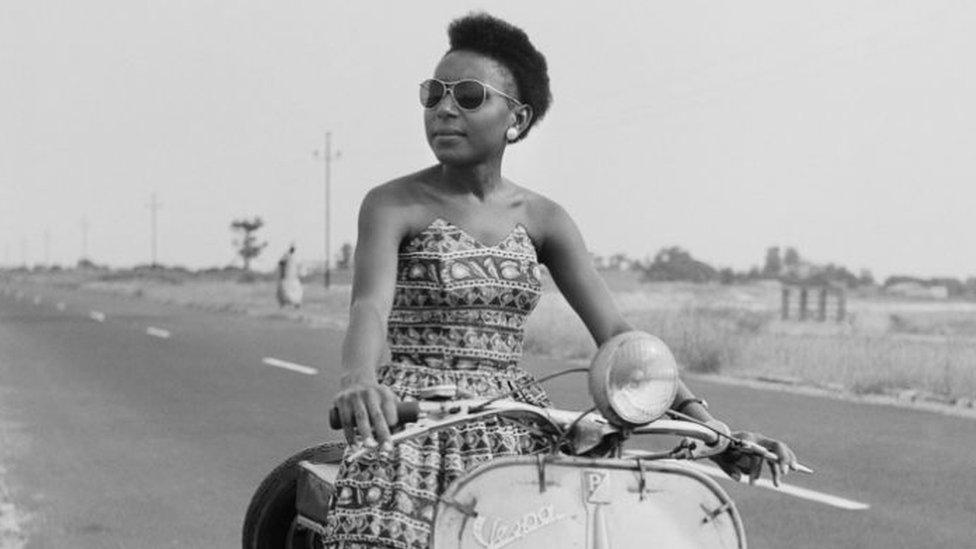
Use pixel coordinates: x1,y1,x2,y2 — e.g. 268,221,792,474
324,219,549,549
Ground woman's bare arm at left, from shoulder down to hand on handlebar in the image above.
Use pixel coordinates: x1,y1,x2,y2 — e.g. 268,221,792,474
335,187,406,444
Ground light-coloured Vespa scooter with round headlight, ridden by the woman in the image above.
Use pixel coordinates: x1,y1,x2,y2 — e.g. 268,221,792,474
243,332,812,549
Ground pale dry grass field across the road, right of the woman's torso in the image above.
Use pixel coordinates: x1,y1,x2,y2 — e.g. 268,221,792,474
526,284,976,398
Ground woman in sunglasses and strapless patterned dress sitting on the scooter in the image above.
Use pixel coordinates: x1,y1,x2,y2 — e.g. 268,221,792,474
326,14,794,548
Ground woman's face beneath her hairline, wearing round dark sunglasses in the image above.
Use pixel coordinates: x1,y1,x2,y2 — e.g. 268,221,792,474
424,51,519,166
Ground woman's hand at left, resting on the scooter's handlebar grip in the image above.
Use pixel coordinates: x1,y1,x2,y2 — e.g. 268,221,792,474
335,376,399,447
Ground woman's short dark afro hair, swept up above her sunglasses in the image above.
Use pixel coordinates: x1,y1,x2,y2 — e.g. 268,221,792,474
447,12,552,141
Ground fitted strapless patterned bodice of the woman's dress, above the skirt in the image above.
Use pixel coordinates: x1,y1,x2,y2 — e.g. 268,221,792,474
378,218,542,402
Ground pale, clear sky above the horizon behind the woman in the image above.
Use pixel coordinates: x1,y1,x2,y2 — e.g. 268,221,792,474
0,0,976,277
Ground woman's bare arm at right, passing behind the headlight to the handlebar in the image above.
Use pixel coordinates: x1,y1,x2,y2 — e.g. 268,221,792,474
538,202,796,484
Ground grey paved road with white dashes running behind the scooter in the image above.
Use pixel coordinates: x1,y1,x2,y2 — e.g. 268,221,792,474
0,283,976,548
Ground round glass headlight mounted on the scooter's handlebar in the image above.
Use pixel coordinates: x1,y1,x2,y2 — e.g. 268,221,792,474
590,331,678,427
